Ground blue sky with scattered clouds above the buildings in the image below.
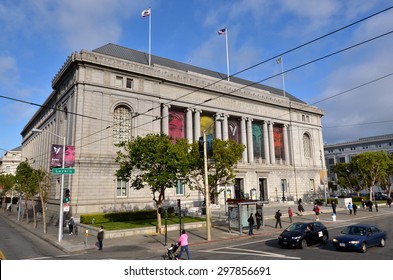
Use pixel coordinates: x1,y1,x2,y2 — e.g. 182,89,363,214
0,0,393,155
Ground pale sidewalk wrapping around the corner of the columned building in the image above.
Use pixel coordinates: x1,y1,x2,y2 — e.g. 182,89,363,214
0,204,345,253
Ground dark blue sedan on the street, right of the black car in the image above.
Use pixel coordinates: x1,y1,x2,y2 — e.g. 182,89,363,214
332,224,386,253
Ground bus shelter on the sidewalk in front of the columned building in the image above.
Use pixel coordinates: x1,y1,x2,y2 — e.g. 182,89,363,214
228,199,264,235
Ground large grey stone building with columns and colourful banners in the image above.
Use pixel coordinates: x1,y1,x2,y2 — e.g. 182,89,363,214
21,44,324,217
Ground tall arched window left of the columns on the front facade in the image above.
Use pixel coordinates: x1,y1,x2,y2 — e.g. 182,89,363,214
113,105,132,144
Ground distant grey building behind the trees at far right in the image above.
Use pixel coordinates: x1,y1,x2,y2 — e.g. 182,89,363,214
324,134,393,191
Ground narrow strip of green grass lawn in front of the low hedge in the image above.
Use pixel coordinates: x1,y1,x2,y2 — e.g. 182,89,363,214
86,217,206,230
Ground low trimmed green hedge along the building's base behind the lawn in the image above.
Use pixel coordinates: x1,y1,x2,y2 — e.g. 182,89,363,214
80,209,157,224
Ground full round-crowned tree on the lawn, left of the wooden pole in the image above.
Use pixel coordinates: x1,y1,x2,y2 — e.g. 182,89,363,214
115,134,189,232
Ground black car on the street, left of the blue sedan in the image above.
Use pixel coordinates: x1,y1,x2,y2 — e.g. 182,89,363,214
278,222,329,249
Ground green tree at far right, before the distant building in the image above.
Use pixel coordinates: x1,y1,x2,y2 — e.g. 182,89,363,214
352,151,388,200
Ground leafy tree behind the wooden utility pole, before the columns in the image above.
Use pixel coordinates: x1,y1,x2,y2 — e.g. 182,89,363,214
189,139,245,202
